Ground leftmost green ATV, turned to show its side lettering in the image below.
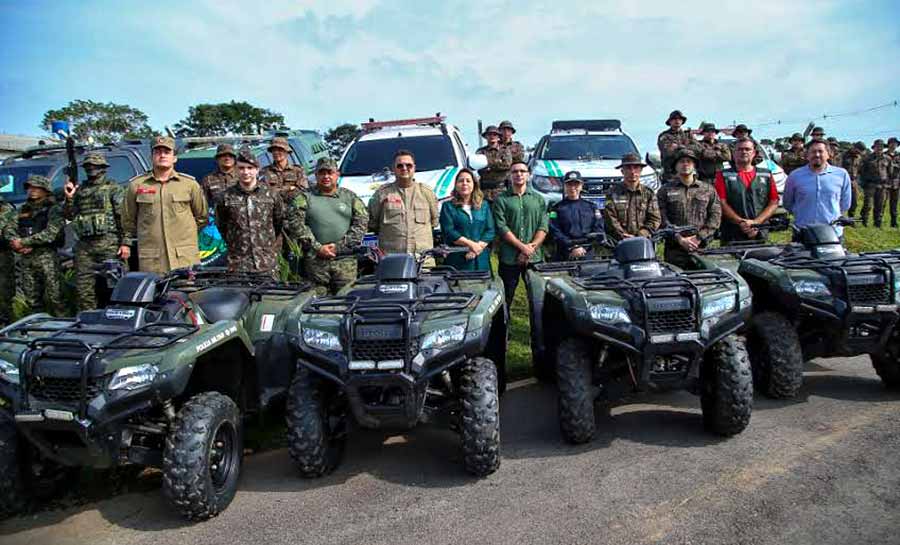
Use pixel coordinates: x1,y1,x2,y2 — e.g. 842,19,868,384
0,269,310,520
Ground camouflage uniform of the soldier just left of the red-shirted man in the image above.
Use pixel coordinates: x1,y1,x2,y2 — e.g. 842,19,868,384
657,173,722,268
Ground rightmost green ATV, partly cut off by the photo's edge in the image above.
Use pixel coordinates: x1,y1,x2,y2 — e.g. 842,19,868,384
695,217,900,398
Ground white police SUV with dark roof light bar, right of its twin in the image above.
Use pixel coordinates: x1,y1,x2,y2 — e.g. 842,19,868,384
530,119,659,208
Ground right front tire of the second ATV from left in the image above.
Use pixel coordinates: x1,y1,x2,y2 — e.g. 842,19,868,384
459,358,500,477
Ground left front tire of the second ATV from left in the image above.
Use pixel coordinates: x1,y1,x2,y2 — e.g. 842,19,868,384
286,368,346,478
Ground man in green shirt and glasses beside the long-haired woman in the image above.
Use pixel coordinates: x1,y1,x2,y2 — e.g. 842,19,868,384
493,161,550,308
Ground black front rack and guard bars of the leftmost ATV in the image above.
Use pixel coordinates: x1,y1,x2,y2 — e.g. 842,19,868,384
0,317,198,419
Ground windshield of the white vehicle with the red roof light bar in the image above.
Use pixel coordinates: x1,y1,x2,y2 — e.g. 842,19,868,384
341,134,459,176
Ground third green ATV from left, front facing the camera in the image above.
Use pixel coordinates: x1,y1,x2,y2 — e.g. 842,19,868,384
528,227,753,444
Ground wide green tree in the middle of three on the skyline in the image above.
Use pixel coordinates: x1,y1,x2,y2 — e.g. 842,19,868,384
174,100,284,136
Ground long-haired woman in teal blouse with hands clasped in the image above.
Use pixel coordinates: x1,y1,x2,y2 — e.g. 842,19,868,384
441,168,494,271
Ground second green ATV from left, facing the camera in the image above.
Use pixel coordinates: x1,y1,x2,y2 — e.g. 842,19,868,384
287,247,508,477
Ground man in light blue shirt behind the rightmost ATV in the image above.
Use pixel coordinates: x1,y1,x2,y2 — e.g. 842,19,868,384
783,140,852,236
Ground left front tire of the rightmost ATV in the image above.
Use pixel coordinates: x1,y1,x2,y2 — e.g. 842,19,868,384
748,312,803,399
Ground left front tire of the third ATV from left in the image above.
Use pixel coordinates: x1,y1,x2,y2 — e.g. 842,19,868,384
556,337,597,445
